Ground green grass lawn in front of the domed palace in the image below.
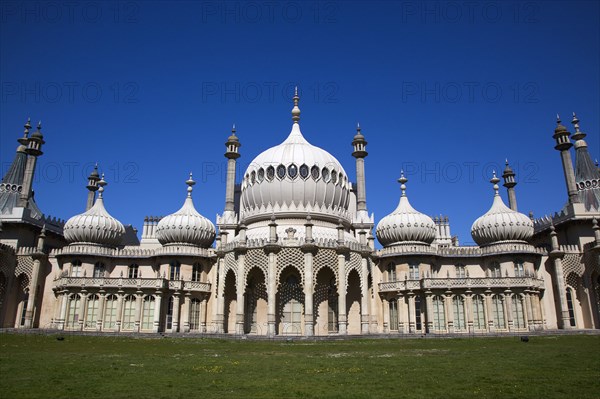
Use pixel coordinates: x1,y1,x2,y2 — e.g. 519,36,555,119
0,334,600,399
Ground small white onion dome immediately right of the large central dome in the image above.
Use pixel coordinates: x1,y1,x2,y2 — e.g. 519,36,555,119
376,173,436,246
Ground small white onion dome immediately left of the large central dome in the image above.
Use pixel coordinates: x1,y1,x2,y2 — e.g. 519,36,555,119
156,173,216,248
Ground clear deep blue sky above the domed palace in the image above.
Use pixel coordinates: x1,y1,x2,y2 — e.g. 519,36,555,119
0,1,600,244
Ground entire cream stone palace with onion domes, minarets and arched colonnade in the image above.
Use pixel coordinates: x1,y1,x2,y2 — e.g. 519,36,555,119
0,94,600,337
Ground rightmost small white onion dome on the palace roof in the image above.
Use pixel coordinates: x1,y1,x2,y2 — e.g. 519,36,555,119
471,172,533,246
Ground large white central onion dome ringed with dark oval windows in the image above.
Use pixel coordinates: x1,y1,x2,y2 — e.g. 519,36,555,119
240,88,351,223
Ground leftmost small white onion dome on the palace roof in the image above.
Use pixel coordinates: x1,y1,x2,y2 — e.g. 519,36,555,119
64,179,125,247
